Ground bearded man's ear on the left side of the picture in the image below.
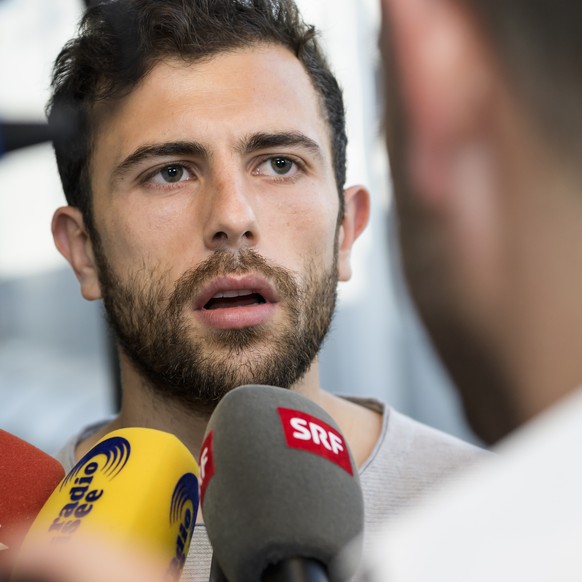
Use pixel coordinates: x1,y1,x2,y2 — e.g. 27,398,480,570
52,206,101,301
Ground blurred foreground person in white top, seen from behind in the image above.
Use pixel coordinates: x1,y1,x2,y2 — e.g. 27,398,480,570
377,0,582,582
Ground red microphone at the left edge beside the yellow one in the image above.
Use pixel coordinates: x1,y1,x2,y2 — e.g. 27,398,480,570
0,430,65,579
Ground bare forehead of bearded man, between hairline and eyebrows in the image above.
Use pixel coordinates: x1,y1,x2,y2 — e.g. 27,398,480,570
93,45,331,170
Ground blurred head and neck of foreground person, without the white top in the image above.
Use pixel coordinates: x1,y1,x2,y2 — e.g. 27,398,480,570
382,0,582,442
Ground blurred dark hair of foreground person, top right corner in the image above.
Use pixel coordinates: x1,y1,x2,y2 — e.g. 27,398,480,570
468,0,582,157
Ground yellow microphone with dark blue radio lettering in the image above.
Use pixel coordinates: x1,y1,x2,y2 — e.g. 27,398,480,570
16,428,199,582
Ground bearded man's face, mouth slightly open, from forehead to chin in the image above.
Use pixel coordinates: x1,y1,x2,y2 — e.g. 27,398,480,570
84,46,343,409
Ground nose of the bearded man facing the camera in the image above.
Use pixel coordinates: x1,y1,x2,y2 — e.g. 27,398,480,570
204,170,259,250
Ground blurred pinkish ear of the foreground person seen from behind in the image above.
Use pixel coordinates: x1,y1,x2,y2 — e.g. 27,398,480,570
382,0,495,210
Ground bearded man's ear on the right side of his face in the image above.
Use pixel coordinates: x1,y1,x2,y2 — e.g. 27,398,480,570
338,186,370,281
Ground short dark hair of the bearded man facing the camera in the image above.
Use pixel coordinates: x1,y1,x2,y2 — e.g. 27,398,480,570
47,0,347,230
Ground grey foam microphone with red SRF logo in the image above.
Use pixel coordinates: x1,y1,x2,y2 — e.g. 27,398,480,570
199,386,364,582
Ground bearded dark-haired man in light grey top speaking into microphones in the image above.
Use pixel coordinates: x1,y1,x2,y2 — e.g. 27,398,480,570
49,0,479,580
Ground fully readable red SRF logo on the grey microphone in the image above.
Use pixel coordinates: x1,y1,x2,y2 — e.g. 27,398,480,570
277,408,354,475
